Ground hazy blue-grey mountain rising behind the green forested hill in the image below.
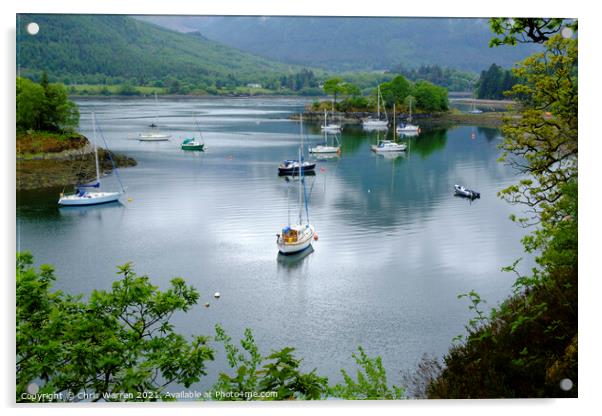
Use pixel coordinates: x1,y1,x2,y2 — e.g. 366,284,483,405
137,16,536,72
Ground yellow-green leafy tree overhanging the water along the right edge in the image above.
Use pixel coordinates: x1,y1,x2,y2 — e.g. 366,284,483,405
500,35,578,224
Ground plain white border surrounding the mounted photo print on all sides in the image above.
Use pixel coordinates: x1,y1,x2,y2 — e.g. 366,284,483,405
0,0,602,416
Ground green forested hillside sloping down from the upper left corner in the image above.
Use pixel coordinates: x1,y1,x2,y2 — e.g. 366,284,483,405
17,14,298,86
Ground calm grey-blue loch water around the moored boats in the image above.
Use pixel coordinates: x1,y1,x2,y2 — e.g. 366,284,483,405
17,99,532,387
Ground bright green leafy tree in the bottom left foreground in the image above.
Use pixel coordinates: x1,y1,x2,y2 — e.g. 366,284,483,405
16,253,214,401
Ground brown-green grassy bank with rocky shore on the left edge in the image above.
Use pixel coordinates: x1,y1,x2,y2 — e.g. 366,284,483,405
16,132,136,190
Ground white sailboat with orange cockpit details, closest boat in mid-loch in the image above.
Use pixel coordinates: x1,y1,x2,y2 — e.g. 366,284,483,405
276,146,316,254
